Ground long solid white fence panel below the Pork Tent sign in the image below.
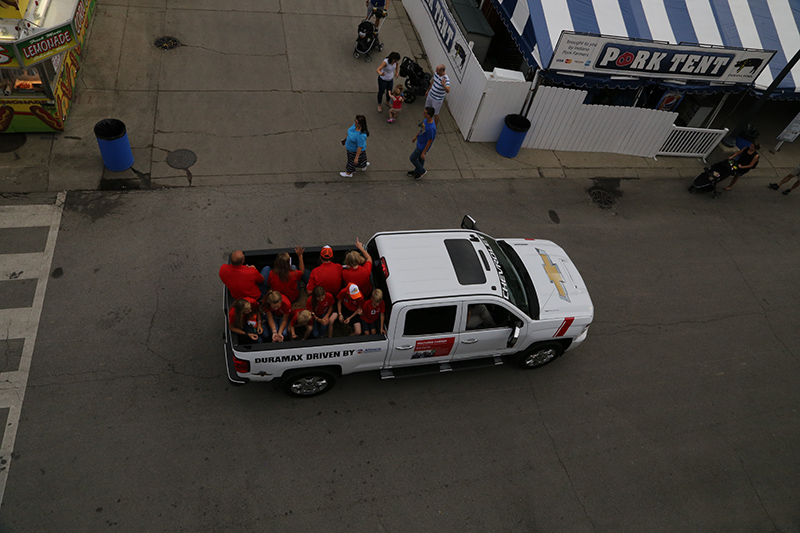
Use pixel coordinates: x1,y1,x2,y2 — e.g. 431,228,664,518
523,87,678,157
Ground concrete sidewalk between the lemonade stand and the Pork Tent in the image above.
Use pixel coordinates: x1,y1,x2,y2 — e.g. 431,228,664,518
0,0,800,192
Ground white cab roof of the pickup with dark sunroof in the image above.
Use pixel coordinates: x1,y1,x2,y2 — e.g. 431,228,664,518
373,230,502,302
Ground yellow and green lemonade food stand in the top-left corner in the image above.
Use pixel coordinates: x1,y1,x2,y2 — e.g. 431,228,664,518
0,0,96,133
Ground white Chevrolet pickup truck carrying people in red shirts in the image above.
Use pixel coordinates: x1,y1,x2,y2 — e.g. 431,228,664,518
223,216,594,397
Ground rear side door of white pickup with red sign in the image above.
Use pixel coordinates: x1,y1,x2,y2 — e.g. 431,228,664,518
389,303,460,366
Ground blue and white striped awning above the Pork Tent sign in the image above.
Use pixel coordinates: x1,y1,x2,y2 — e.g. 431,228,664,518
492,0,800,92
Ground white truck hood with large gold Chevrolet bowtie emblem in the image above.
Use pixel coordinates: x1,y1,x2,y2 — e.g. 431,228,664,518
503,239,594,320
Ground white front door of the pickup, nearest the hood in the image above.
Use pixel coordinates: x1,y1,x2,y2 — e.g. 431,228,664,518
454,301,528,360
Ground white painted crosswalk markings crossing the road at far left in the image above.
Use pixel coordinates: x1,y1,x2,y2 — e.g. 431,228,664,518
0,192,67,505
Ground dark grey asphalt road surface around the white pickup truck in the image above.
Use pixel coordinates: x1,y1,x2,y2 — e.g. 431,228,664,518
0,178,800,533
